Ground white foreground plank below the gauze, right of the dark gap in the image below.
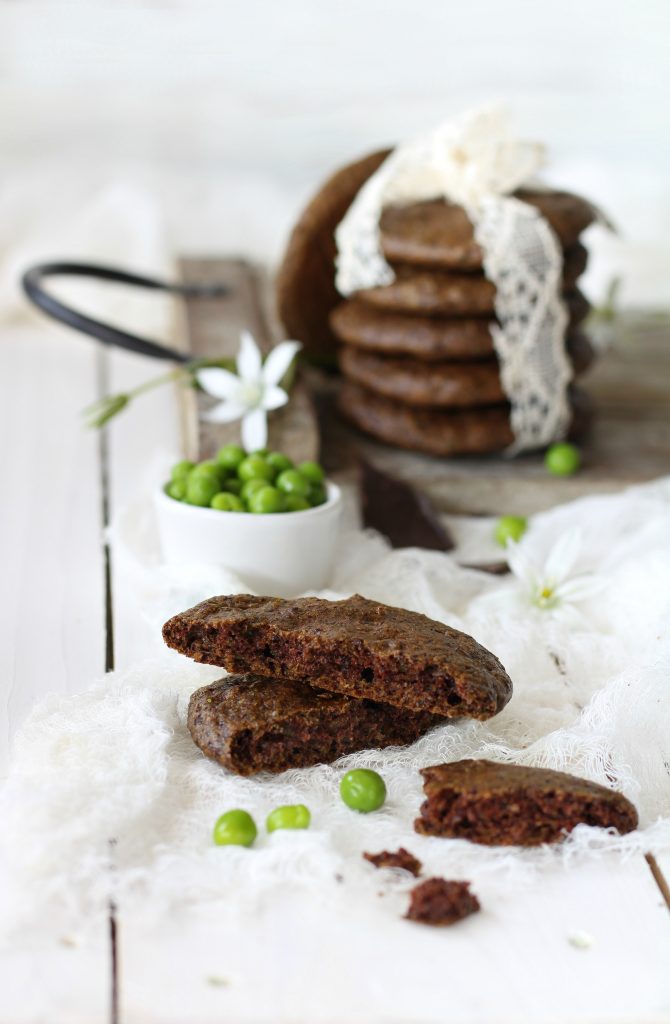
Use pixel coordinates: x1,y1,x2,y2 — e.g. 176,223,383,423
121,858,670,1024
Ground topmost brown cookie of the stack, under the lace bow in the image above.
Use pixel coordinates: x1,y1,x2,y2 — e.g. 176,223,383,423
380,189,597,270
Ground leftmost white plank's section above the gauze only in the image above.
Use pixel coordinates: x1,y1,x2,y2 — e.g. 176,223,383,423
0,328,104,774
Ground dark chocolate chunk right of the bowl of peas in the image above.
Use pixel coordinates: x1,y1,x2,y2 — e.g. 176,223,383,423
361,460,454,551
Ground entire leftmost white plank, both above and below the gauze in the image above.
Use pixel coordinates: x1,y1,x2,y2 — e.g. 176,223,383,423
0,326,110,1024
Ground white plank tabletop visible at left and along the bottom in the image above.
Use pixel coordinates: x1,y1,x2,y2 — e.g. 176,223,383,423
0,315,670,1024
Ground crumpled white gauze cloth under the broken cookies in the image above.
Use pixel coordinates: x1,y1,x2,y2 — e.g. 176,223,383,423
0,478,670,935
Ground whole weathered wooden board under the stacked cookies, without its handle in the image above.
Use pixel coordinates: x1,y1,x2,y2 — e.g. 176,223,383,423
181,260,670,515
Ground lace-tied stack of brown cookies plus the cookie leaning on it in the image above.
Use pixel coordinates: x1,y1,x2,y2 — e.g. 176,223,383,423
278,154,595,456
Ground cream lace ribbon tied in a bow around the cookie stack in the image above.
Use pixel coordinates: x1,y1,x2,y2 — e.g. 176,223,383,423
335,106,572,454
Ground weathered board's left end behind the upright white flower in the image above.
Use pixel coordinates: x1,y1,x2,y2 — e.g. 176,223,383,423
180,259,319,462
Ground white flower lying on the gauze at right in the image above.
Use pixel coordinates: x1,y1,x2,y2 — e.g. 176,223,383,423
507,529,600,609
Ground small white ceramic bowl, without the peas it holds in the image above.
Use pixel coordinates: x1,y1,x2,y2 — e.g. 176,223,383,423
154,483,342,597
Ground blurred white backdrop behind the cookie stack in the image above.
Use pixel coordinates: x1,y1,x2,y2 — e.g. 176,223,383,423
0,0,670,305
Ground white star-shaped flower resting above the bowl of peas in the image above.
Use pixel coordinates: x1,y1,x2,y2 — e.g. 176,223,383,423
196,331,301,452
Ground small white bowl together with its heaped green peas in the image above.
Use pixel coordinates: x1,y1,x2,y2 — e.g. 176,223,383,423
155,444,341,597
